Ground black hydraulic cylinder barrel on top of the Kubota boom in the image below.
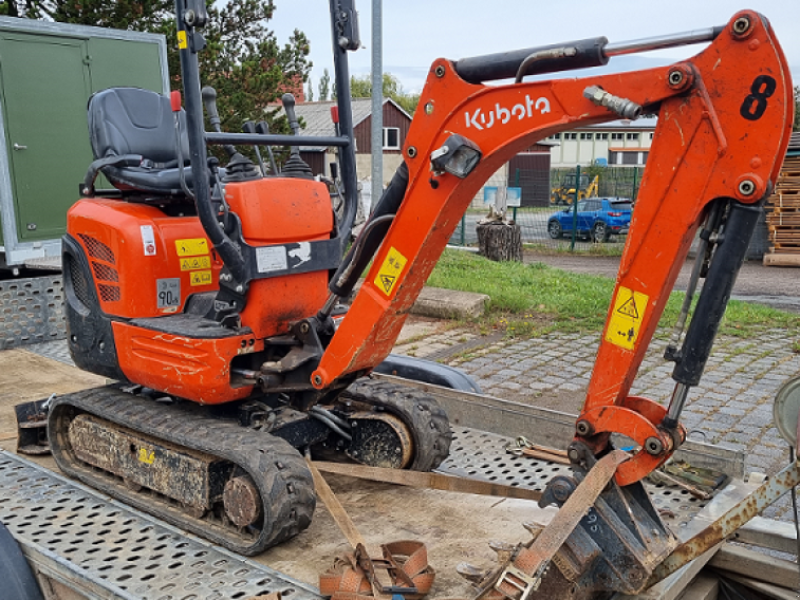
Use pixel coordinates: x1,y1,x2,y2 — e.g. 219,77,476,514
455,37,608,83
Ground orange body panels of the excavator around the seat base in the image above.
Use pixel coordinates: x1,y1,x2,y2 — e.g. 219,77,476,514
67,178,333,404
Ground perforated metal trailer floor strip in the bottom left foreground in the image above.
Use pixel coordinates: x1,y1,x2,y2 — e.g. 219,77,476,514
0,452,321,600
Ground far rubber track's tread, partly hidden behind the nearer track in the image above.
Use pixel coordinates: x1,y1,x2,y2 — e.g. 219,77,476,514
339,378,453,471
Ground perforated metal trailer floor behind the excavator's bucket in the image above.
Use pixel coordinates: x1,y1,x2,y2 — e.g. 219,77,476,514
438,427,710,538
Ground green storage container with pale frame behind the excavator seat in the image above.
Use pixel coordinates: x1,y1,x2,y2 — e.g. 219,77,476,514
0,18,169,266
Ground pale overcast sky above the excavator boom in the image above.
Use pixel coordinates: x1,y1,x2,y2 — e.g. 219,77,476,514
270,0,800,96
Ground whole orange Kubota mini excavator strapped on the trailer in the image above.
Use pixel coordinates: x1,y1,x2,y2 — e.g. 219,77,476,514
39,0,793,600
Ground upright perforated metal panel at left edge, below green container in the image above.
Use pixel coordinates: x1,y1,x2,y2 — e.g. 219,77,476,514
0,274,67,350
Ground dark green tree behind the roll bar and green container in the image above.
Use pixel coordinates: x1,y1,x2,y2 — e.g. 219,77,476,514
0,0,312,133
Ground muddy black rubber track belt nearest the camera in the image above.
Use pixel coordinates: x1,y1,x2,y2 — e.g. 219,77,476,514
48,387,316,556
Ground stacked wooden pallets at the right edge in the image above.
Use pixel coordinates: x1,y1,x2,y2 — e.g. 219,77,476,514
764,134,800,267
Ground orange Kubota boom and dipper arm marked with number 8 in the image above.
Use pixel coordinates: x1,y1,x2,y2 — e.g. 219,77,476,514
312,11,793,485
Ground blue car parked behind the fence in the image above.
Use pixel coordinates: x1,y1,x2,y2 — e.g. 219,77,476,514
547,198,632,243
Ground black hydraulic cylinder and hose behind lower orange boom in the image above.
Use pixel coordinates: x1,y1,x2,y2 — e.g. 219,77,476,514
328,162,408,297
